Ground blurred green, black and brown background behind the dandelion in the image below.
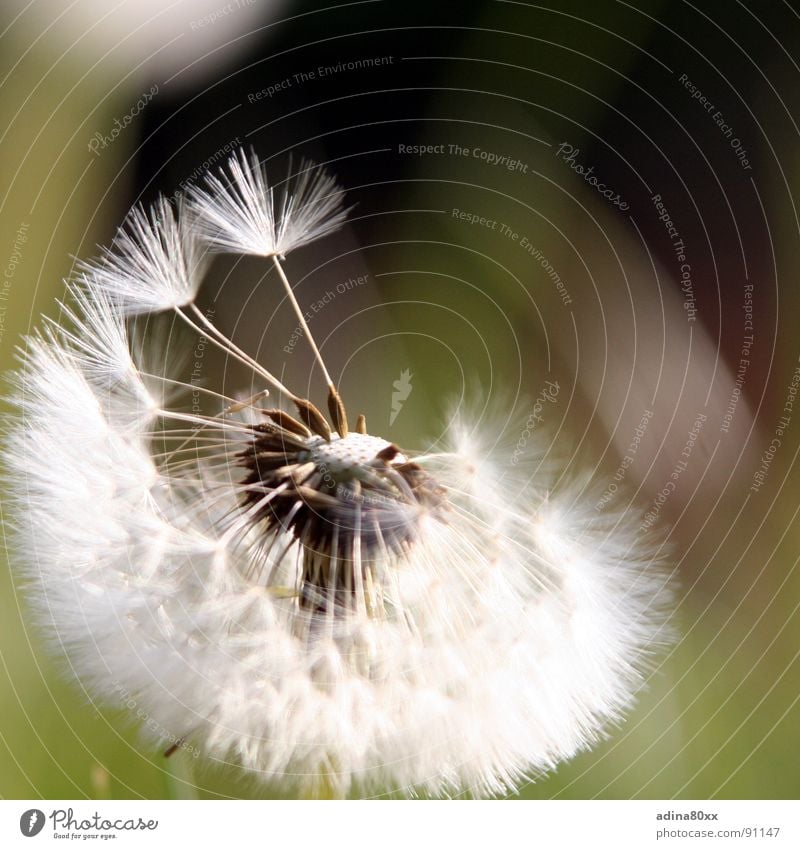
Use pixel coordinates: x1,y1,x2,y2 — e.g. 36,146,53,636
0,0,800,799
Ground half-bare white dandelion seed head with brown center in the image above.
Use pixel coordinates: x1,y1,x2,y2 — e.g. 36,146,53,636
7,151,668,796
